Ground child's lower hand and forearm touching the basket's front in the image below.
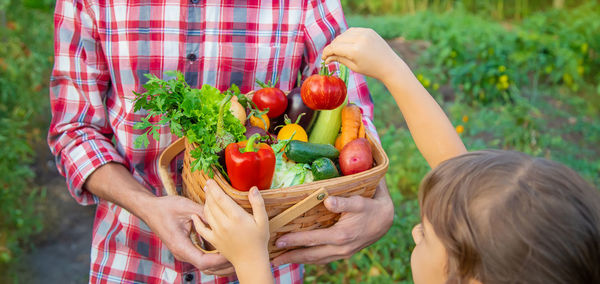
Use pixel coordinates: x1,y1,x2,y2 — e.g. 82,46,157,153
192,180,273,283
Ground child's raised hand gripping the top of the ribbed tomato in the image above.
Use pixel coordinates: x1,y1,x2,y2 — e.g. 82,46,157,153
322,28,405,83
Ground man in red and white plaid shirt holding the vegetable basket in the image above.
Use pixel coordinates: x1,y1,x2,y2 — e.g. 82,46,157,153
48,0,393,283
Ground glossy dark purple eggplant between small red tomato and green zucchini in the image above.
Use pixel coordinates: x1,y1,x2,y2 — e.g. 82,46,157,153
269,88,317,134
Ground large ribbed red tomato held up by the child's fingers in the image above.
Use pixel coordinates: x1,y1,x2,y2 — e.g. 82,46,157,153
300,74,346,110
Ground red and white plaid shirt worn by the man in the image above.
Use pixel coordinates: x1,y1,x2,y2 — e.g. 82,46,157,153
48,0,374,283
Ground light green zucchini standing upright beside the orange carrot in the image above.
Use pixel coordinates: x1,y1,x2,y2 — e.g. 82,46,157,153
308,100,347,145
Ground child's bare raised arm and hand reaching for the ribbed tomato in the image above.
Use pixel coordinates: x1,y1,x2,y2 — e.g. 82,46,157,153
323,28,467,168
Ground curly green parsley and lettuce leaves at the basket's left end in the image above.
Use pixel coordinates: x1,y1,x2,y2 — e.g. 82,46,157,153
134,71,245,175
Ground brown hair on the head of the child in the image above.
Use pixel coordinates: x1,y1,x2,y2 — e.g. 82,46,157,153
419,151,600,284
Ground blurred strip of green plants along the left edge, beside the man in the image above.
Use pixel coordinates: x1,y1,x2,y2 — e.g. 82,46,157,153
0,1,52,276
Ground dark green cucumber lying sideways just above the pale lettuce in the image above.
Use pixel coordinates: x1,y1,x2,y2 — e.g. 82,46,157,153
285,140,340,164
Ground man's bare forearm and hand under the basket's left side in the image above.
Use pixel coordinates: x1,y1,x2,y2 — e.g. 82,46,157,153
84,163,234,275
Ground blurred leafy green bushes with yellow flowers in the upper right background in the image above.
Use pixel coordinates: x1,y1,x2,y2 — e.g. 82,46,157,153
349,3,600,104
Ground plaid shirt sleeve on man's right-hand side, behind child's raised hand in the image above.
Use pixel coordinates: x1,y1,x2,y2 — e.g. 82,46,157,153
301,0,379,139
